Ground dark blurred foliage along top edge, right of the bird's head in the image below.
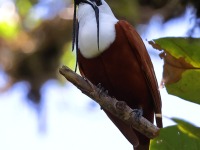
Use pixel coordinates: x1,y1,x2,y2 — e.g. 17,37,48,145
107,0,200,25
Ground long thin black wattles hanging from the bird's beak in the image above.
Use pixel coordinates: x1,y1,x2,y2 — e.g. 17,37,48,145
72,0,99,51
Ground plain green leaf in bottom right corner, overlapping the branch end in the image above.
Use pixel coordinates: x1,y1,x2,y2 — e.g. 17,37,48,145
150,125,200,150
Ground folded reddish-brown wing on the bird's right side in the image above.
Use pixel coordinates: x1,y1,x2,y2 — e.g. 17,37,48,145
118,20,162,128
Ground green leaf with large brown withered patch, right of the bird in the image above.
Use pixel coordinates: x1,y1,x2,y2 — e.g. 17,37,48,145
149,38,200,104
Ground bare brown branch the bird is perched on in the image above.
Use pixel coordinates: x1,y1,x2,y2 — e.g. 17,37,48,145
59,66,159,139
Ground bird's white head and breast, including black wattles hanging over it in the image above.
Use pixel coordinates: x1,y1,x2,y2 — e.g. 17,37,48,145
72,0,118,58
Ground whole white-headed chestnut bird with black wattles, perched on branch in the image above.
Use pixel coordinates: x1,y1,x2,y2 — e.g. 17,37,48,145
72,0,163,150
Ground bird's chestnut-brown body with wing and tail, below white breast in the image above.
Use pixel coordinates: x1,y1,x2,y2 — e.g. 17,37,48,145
78,21,162,149
